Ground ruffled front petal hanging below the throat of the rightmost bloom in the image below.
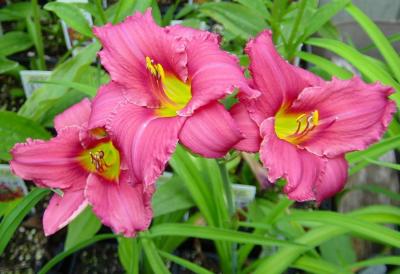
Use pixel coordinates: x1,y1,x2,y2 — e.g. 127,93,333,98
260,118,327,201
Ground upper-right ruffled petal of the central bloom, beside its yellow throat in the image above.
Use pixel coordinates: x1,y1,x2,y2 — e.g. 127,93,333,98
179,34,259,116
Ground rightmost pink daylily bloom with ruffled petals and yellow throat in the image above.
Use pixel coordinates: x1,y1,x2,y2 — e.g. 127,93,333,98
231,31,396,202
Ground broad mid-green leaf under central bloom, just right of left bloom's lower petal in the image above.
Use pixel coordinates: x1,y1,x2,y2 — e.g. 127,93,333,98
152,176,194,217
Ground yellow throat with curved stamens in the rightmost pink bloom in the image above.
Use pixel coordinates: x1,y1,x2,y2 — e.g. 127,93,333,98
275,107,319,144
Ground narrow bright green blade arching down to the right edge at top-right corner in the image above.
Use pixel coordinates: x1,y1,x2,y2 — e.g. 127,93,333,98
346,4,400,81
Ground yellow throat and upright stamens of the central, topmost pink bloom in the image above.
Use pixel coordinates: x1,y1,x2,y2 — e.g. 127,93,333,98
146,56,192,117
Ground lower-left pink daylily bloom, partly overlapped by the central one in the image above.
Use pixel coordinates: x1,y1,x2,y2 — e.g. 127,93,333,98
10,99,153,236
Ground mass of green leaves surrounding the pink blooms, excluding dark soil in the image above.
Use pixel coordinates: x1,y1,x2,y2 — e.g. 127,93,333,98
0,0,400,274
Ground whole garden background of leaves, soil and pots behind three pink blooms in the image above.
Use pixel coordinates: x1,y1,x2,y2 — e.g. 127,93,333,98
0,0,400,274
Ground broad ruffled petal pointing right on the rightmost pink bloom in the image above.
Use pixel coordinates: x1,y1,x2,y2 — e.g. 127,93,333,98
292,78,396,157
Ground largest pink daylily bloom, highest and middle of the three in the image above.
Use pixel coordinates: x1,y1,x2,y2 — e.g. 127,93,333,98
89,10,258,185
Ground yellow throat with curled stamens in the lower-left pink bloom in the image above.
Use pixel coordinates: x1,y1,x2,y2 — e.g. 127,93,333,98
78,141,120,183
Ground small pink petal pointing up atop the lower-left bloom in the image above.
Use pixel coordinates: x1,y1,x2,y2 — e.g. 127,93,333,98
54,98,91,131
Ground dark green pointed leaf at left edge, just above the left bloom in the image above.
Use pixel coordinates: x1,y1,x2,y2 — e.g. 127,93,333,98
0,111,51,161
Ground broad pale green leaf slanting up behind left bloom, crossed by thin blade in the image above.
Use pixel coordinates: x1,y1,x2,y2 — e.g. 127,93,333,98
18,42,100,124
